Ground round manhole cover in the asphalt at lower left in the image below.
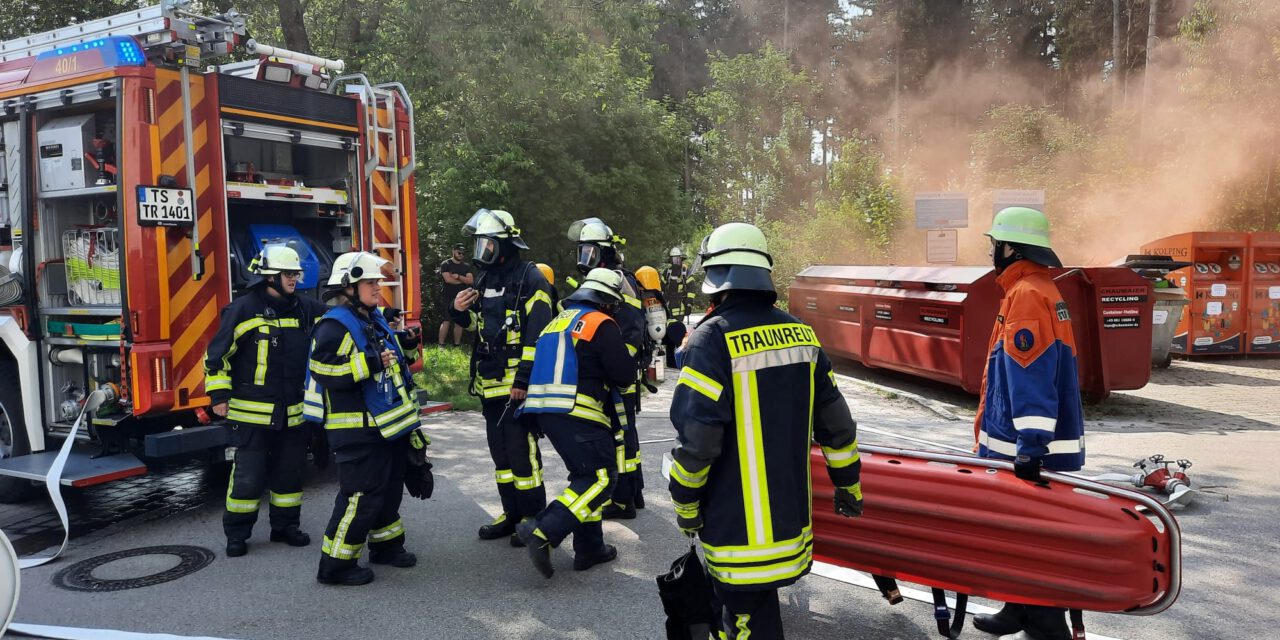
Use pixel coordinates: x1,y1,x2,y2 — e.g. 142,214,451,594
54,545,214,593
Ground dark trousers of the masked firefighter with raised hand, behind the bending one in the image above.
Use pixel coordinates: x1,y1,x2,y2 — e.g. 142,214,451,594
481,398,547,522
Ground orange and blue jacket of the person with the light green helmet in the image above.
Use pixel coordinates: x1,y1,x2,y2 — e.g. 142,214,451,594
974,260,1084,471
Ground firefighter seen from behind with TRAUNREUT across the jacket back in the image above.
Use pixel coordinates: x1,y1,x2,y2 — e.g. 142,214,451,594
669,223,863,639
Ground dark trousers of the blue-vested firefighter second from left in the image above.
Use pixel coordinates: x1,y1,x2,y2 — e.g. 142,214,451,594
320,438,408,579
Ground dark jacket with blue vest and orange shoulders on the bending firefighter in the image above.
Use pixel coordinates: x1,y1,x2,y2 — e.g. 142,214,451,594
524,302,635,429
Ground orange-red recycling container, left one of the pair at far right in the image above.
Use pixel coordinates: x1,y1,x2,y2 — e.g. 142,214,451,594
1142,232,1249,356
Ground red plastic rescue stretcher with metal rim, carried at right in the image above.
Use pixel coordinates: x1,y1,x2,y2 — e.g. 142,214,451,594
810,445,1181,637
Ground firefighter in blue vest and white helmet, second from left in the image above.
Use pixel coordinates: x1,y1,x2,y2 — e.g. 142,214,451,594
306,251,431,585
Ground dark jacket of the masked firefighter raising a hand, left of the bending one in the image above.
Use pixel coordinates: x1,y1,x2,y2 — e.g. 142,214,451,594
449,259,554,401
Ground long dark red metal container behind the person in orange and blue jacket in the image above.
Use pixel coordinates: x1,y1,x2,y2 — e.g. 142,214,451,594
790,265,1152,399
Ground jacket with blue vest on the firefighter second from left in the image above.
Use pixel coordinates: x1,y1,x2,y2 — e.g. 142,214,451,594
305,305,420,449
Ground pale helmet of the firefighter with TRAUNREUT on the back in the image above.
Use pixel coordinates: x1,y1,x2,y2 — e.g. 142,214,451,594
698,223,776,293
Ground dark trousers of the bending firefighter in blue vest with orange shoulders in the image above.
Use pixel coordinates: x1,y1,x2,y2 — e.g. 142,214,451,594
524,413,617,556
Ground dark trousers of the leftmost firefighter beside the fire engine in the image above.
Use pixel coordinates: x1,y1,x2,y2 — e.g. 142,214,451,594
223,424,311,540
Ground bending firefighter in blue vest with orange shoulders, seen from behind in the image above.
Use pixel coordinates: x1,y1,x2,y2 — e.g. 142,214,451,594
506,269,635,577
